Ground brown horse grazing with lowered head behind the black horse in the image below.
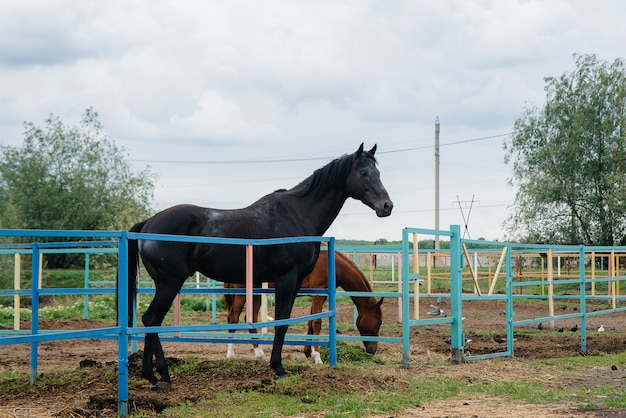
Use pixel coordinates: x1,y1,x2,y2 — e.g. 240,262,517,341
224,251,383,364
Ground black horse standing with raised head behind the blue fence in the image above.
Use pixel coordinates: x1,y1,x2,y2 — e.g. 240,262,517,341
128,144,393,389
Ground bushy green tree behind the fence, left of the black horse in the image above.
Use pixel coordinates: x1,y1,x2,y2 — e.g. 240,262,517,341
0,108,154,250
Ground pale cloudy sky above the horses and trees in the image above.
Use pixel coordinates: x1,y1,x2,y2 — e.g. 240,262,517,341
0,0,626,240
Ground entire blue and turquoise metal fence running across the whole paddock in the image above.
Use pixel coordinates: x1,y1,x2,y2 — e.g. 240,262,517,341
0,225,626,415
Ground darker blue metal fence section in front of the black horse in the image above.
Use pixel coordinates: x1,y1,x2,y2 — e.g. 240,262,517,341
0,230,337,416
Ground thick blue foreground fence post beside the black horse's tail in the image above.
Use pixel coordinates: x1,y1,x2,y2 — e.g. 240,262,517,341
117,231,129,417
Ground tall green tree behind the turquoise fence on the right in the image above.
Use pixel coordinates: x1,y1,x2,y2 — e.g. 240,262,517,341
504,55,626,245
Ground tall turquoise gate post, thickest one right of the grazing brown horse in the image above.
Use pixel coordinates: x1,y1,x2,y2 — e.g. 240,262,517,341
450,225,465,363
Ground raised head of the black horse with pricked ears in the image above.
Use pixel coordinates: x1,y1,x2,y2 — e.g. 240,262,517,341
346,144,393,218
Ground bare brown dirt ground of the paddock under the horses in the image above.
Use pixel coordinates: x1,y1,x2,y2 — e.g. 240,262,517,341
0,300,626,418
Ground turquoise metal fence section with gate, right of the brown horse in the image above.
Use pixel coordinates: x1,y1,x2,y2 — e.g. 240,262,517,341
402,230,626,367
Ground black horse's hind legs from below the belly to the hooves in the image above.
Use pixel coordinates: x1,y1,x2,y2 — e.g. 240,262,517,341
141,286,178,390
